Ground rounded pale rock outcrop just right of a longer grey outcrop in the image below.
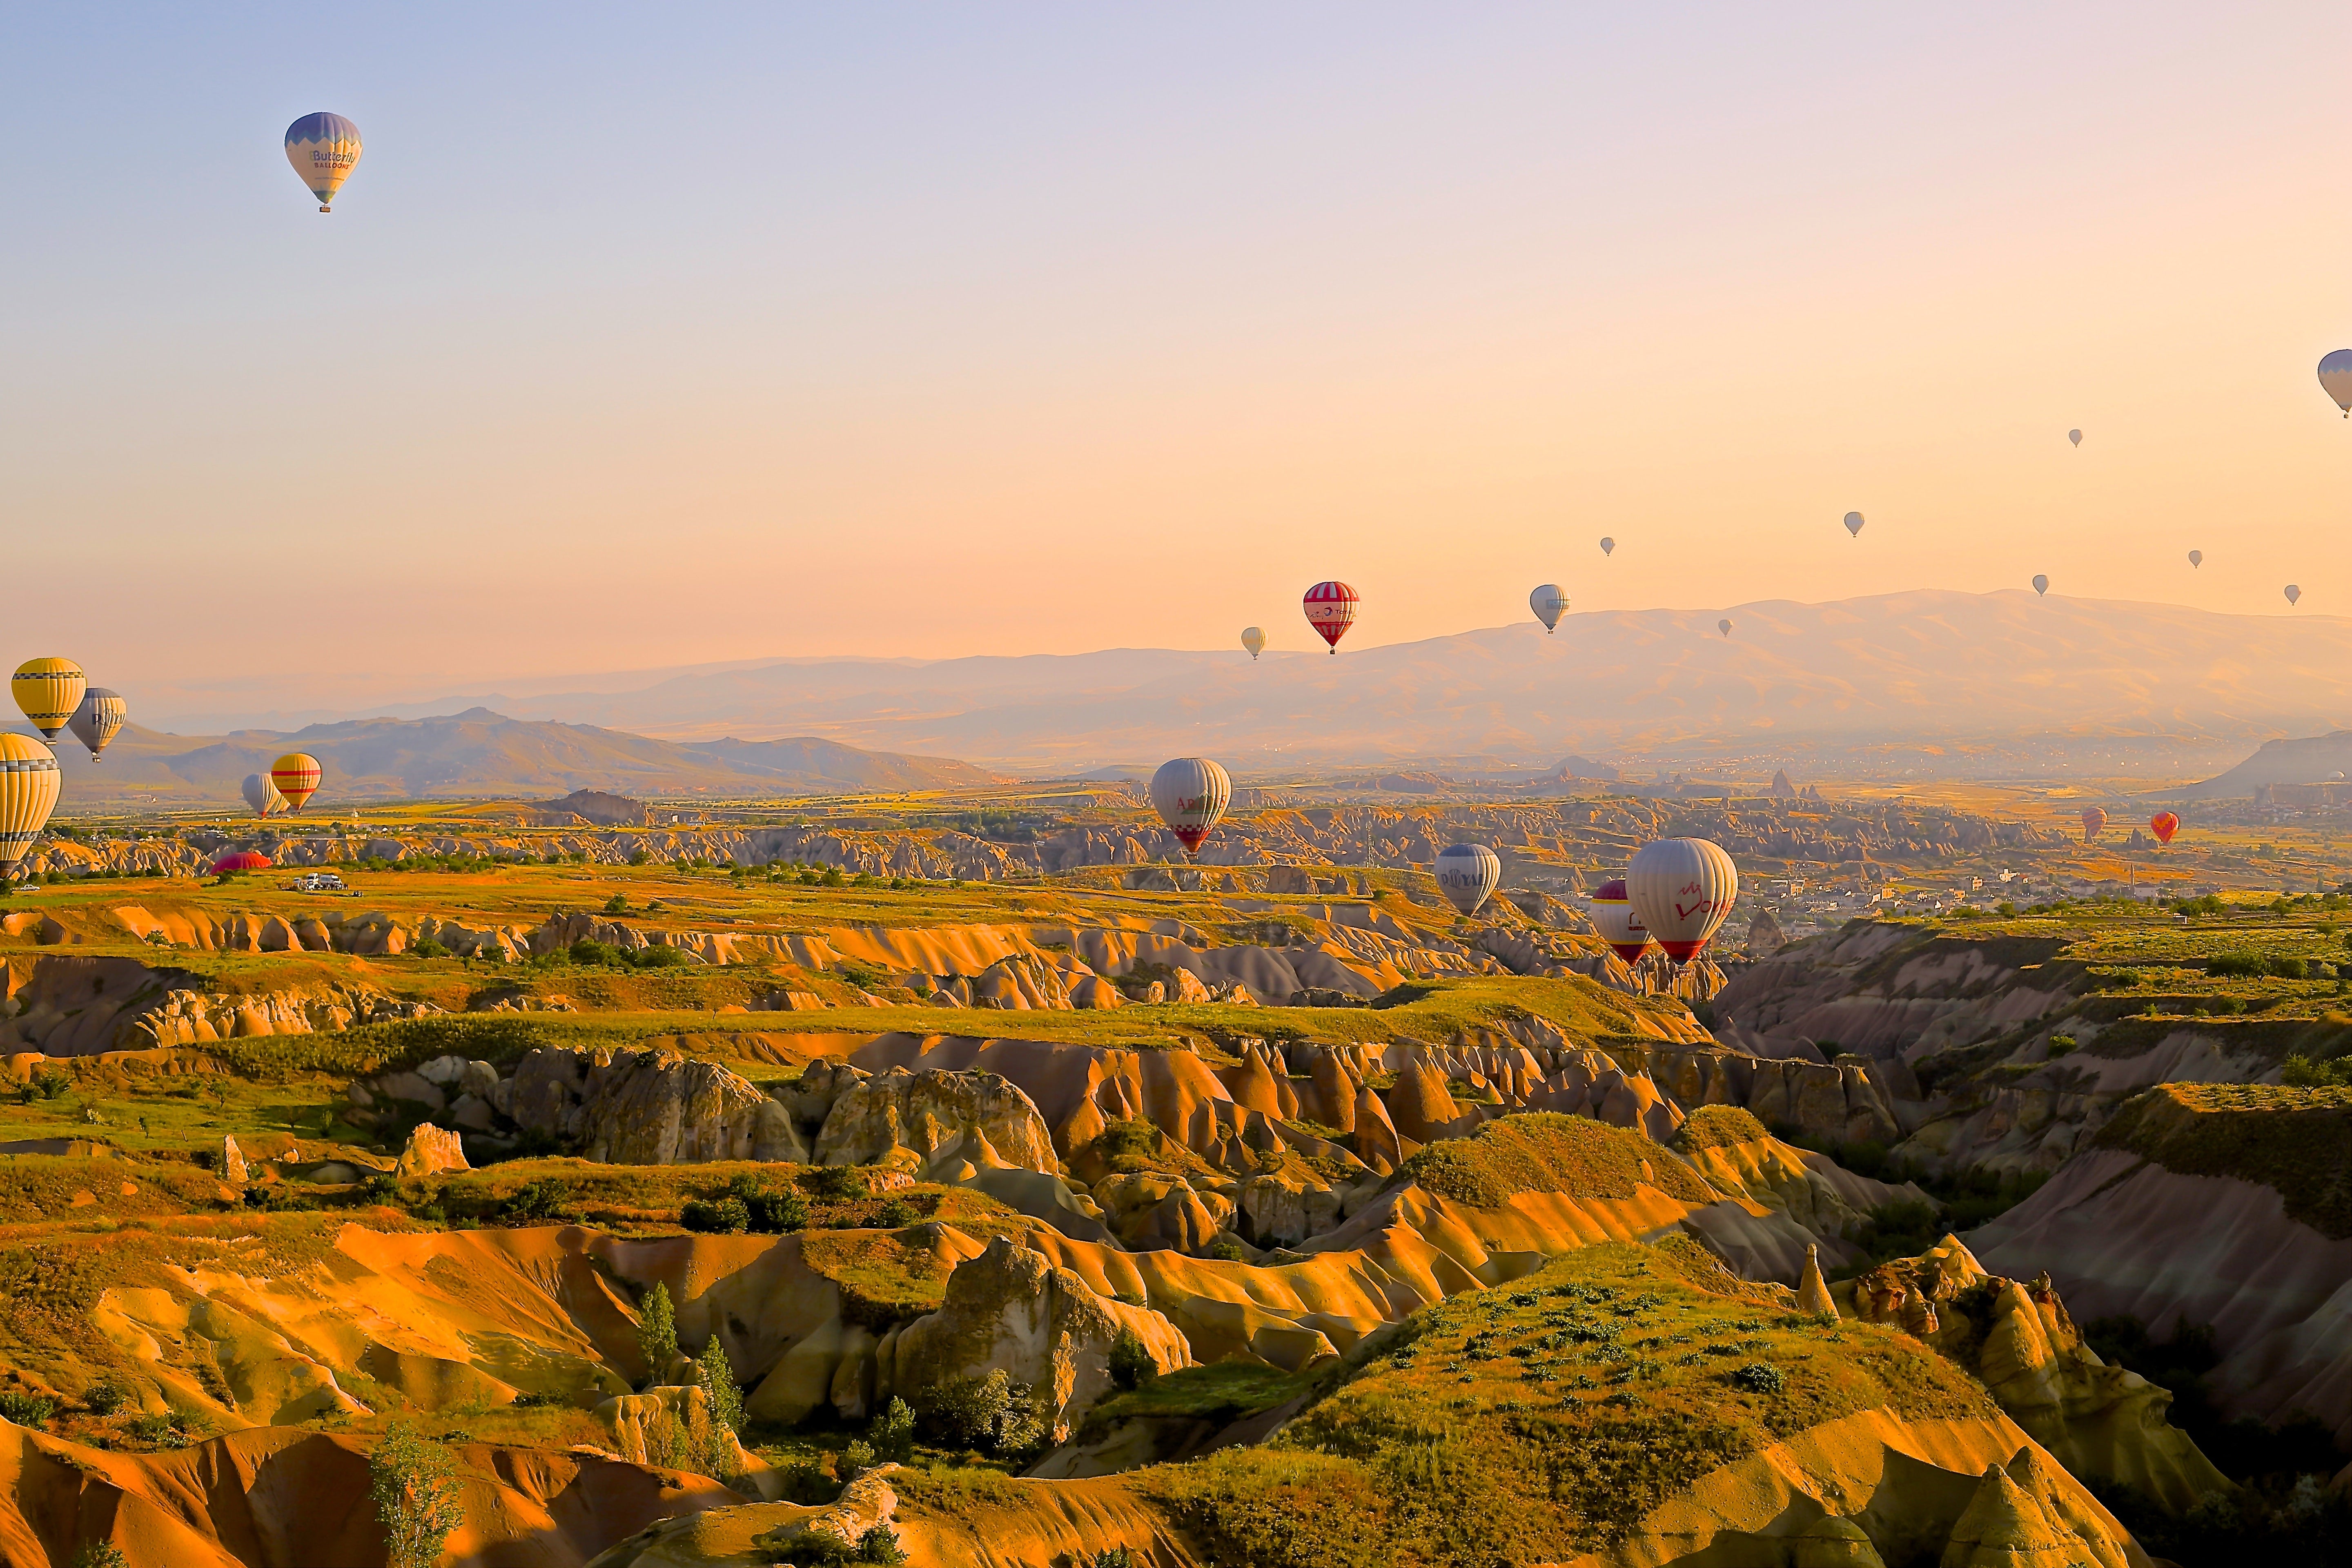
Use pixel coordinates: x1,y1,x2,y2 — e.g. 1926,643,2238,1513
811,1067,1061,1180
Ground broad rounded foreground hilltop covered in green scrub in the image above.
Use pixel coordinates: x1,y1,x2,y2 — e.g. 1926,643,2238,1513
1136,1239,1994,1568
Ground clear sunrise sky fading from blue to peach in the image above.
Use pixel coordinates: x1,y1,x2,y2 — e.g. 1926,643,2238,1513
0,0,2352,705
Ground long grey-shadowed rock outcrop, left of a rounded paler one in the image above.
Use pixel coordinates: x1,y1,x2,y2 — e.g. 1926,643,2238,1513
499,1049,809,1166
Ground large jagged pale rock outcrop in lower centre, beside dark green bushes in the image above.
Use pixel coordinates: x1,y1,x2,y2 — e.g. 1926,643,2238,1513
894,1236,1192,1443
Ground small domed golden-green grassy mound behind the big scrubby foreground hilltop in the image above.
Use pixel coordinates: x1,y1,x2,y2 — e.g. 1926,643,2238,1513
1404,1112,1717,1208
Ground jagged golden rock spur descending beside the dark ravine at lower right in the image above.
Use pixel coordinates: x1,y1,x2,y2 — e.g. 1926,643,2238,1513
1832,1236,2230,1512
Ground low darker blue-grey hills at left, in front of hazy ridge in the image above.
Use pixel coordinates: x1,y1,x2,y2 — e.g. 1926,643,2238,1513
43,708,1002,813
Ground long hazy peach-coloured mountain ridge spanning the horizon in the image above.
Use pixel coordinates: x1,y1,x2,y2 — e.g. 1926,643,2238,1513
343,590,2352,776
